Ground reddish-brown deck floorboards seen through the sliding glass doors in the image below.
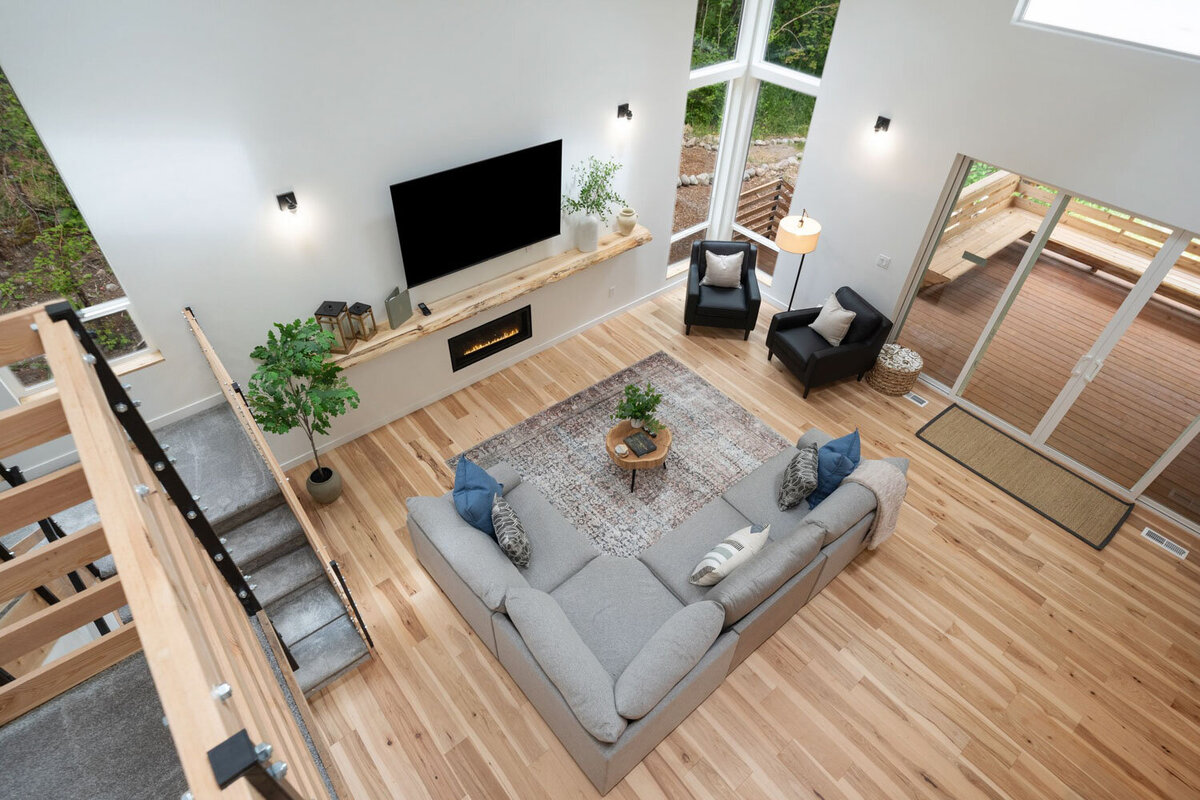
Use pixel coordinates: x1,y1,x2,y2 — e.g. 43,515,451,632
900,243,1200,506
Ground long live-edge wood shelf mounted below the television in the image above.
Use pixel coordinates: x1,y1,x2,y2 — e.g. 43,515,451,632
332,225,653,367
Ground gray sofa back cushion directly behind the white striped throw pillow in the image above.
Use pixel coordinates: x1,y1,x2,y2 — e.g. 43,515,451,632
708,525,823,627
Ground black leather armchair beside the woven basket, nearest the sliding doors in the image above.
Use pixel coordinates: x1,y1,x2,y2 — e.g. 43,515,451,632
767,287,892,397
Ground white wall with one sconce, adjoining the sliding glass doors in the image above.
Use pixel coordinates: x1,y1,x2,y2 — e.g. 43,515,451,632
769,0,1200,313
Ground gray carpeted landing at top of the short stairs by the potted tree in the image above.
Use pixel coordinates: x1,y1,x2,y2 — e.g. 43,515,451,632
155,403,283,533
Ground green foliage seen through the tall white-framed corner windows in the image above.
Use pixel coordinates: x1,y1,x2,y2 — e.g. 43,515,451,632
685,0,838,139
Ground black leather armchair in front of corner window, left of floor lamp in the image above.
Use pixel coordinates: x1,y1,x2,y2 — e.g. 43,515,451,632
683,240,762,339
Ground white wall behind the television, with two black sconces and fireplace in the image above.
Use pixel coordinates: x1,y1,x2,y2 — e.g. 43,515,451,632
0,0,695,465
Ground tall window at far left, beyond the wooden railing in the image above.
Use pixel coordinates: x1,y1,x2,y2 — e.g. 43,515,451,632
0,72,146,397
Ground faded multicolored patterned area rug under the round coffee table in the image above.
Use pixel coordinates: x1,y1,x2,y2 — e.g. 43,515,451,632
448,353,788,555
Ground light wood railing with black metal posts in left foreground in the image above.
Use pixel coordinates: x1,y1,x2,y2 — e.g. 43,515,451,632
0,303,325,800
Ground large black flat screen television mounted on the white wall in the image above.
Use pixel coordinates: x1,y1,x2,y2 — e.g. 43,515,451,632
391,139,563,288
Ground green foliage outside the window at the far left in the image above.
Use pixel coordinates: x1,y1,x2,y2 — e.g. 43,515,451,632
0,72,106,308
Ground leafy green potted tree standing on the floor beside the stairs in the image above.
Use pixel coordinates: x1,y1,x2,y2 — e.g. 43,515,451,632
246,318,359,504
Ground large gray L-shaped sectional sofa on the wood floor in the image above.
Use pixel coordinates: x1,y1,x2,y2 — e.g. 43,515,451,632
408,429,908,794
